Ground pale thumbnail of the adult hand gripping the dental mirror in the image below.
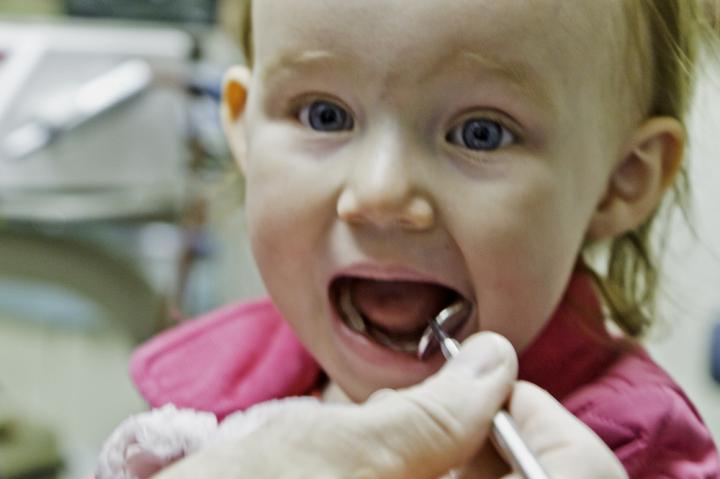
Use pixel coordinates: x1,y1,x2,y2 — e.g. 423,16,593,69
453,333,515,376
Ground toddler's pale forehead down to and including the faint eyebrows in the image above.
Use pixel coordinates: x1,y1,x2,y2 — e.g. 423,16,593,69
253,0,628,124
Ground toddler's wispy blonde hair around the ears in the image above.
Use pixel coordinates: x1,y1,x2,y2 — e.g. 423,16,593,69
233,0,719,337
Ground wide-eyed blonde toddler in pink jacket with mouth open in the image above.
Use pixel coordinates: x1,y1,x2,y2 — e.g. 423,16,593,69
99,0,720,478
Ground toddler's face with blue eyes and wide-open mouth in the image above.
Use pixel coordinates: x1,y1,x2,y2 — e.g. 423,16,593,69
238,0,622,400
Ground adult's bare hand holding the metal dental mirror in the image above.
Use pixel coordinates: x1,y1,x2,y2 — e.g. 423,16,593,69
155,333,625,479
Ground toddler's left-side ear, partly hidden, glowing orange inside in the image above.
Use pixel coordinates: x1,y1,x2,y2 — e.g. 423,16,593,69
221,66,250,171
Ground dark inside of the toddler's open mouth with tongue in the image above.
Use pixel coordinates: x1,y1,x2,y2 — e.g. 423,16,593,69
329,276,465,356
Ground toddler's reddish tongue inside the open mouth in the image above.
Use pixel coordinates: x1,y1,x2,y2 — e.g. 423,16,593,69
351,279,454,333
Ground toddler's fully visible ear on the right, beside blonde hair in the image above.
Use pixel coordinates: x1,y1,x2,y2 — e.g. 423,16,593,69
588,117,685,240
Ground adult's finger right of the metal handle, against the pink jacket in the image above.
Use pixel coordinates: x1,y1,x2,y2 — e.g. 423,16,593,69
504,381,627,479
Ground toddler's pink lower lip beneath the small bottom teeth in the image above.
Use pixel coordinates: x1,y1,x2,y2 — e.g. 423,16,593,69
329,306,444,381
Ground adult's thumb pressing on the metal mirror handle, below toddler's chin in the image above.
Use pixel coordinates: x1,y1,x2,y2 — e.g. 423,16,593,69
363,333,517,478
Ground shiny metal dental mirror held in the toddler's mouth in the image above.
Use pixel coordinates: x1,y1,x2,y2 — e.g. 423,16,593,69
417,301,548,479
